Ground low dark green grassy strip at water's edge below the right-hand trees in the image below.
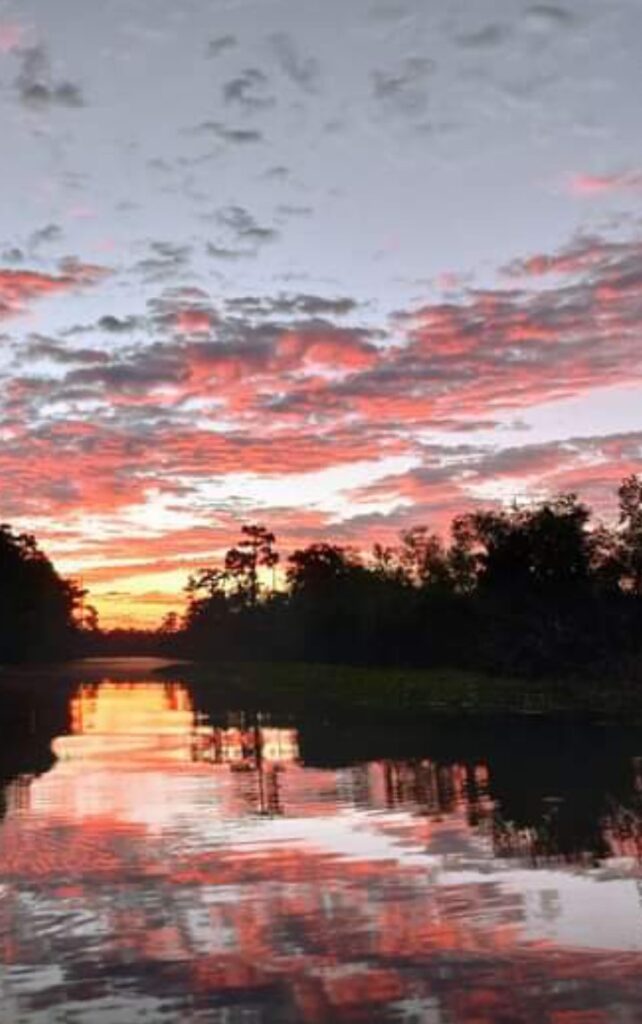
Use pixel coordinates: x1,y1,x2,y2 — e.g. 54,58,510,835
158,663,642,721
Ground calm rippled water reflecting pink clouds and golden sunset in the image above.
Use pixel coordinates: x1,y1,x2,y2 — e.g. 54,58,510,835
0,665,642,1024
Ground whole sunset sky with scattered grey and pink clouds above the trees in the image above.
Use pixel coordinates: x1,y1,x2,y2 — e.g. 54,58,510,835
0,0,642,626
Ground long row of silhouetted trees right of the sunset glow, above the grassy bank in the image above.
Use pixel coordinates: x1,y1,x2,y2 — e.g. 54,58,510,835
174,476,642,675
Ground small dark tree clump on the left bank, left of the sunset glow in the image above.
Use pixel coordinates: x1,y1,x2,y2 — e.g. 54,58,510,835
0,524,83,665
